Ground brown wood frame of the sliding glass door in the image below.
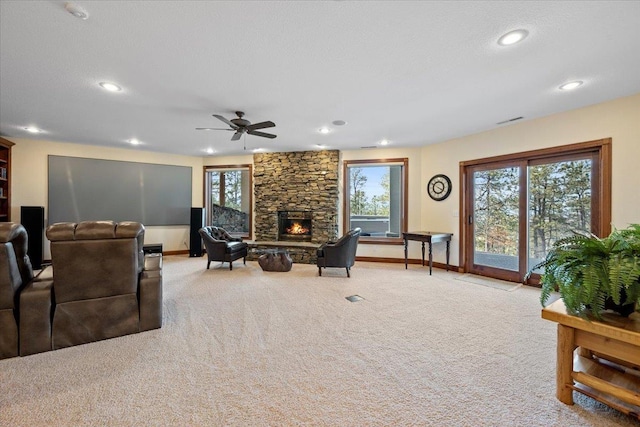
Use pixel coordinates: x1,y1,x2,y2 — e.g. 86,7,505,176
459,138,612,285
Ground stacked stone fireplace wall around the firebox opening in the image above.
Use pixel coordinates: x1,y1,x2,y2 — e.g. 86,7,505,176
253,150,340,243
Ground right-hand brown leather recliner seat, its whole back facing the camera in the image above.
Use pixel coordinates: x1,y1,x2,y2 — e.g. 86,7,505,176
47,221,162,349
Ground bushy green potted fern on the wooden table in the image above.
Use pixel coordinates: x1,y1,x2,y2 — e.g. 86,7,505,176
529,224,640,319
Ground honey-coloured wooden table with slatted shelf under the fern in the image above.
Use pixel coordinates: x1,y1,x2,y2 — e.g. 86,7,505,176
542,299,640,419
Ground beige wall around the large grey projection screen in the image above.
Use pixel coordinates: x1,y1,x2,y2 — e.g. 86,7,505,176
10,138,203,259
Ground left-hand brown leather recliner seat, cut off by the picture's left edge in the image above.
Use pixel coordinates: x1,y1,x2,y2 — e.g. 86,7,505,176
0,222,52,359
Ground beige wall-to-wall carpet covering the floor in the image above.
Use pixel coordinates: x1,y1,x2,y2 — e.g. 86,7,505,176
0,256,639,426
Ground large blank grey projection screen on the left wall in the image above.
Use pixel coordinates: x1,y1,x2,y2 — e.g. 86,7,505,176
48,155,192,225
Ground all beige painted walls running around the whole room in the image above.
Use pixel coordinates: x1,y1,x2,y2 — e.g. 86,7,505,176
10,94,640,265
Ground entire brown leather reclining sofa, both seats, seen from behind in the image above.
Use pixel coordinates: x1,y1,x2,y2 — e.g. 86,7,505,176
0,221,162,359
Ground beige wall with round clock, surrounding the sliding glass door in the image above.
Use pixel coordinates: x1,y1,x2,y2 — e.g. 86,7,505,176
420,94,640,265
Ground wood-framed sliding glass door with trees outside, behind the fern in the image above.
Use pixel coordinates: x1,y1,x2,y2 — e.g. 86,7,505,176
462,140,610,282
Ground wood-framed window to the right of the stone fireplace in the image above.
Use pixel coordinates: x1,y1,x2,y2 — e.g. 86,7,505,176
343,158,408,243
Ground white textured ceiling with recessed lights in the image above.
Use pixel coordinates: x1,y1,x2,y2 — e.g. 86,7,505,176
0,0,640,155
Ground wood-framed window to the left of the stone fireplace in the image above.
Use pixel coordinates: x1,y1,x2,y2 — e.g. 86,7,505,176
204,165,253,237
